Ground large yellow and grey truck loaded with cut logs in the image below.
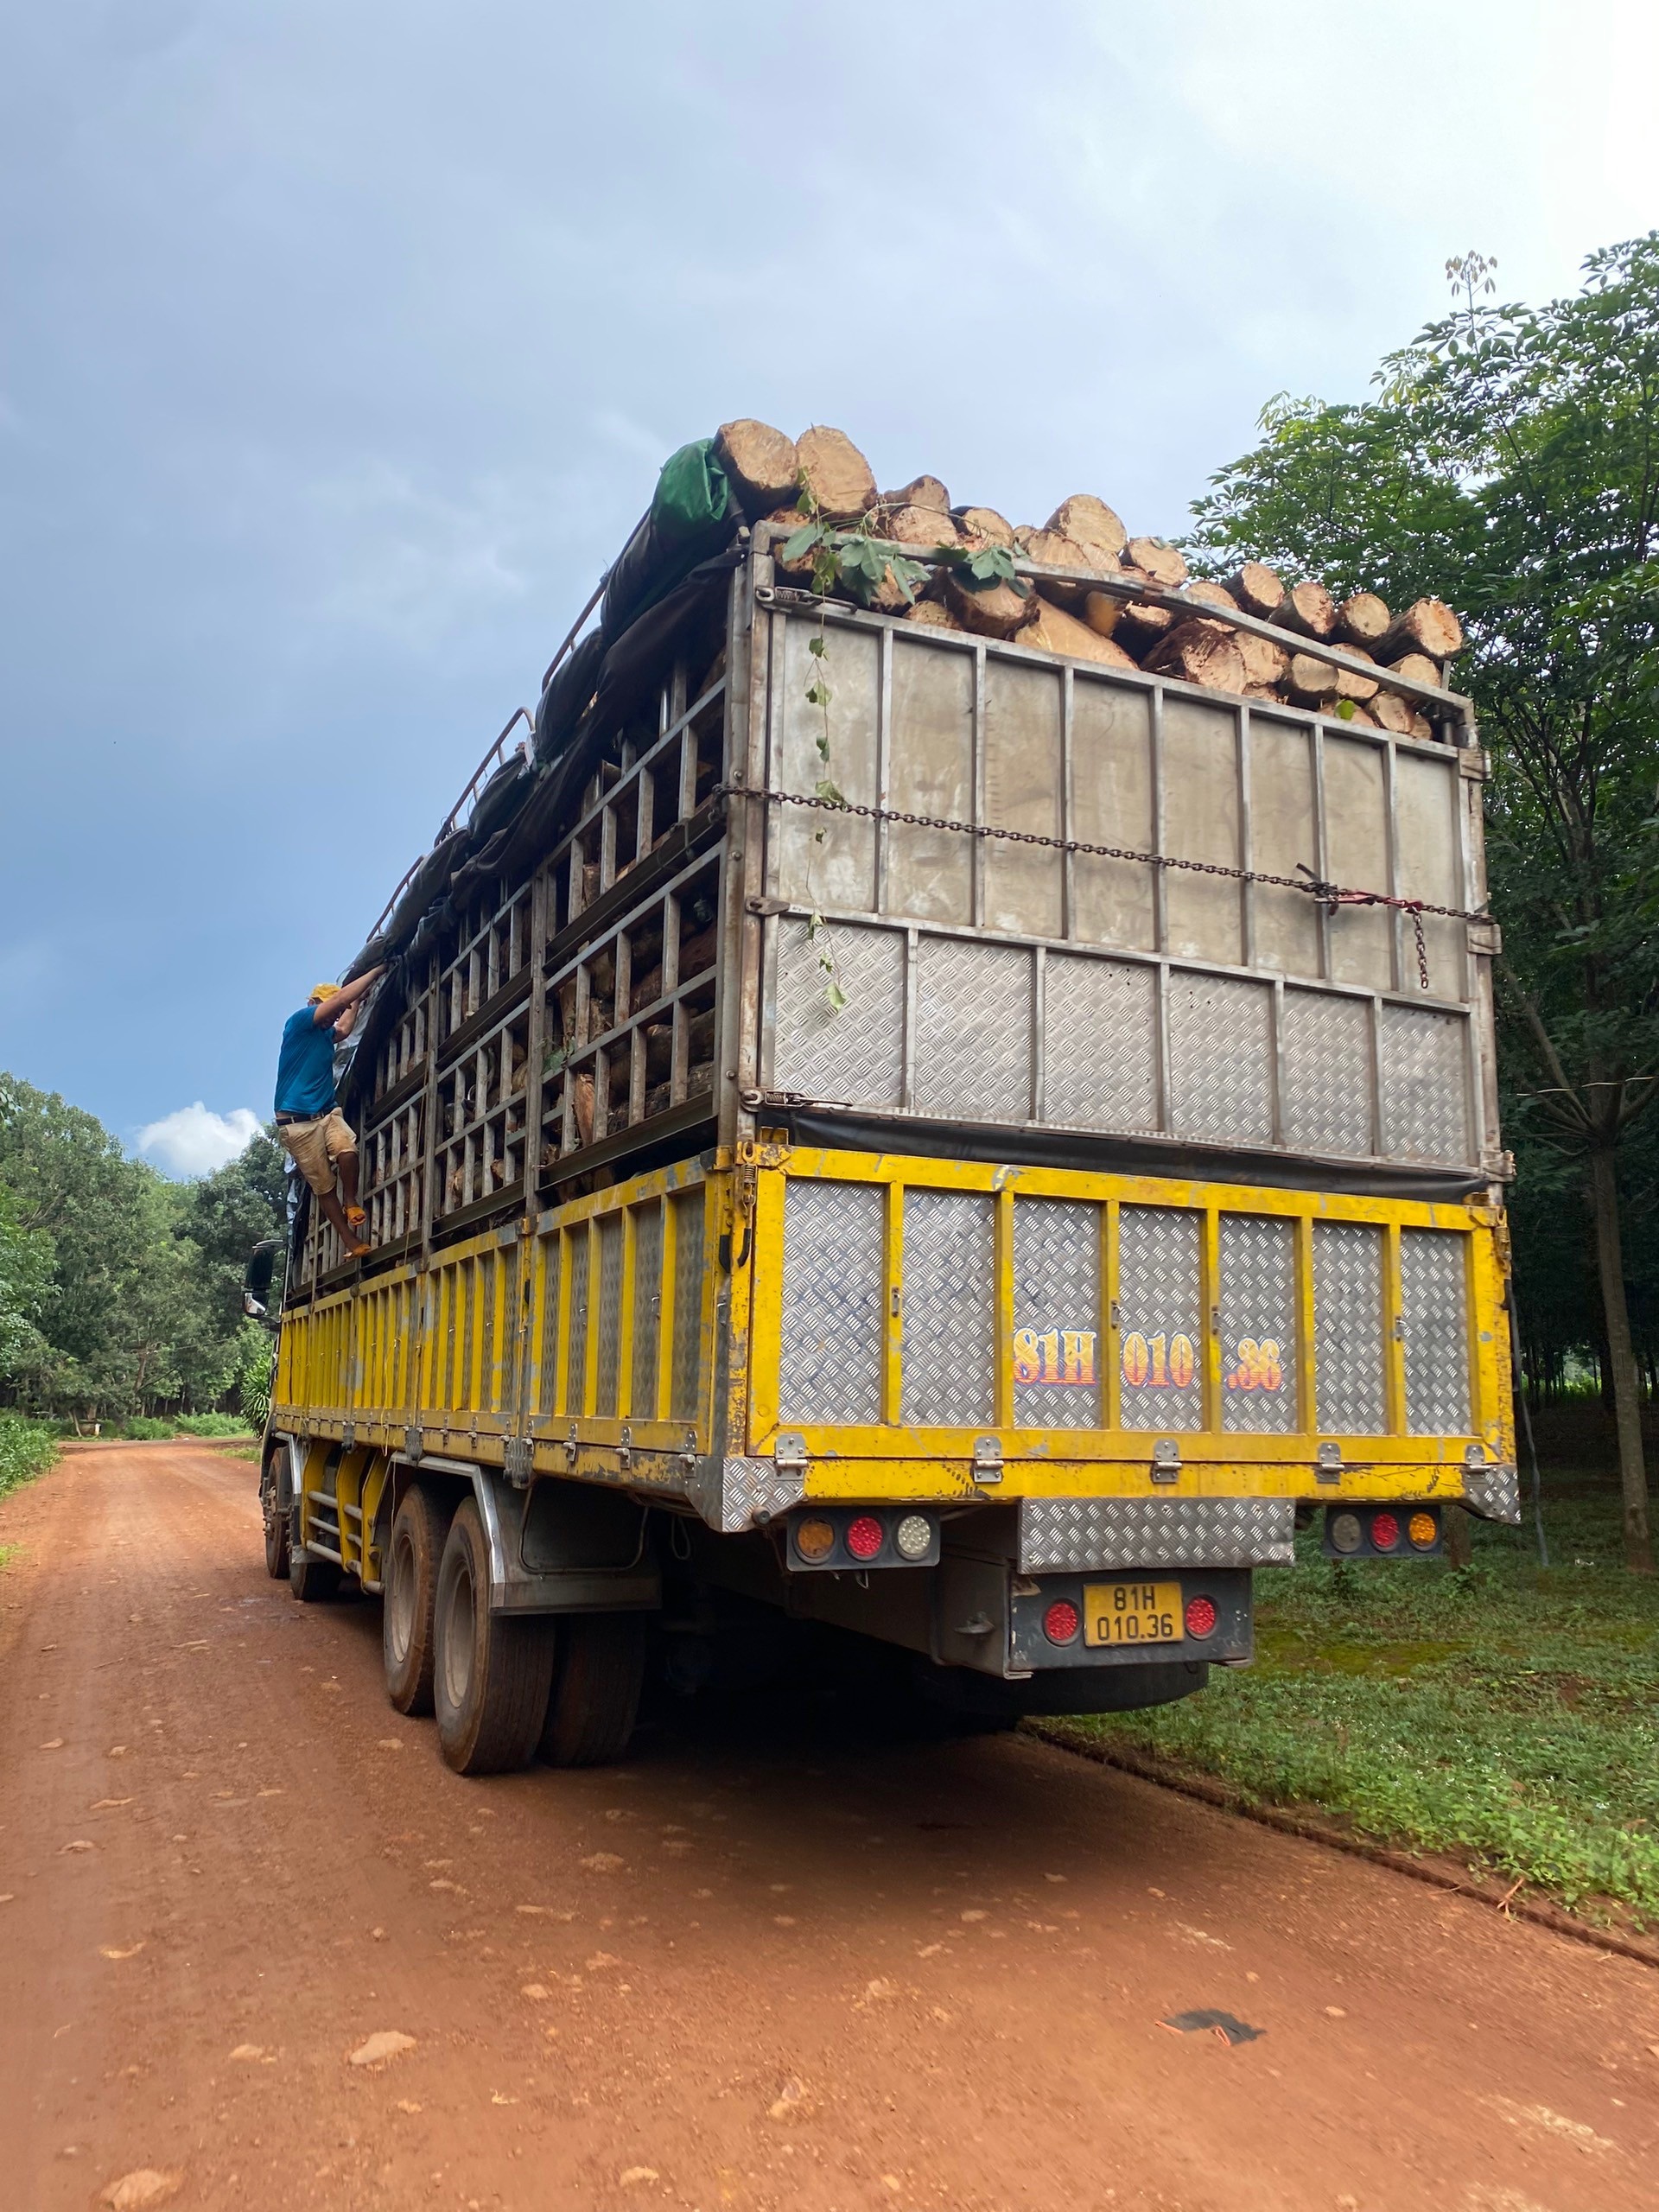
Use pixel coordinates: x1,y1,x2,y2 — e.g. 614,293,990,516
261,423,1517,1774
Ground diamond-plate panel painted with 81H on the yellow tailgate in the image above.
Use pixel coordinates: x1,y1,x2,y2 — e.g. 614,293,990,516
1013,1199,1103,1429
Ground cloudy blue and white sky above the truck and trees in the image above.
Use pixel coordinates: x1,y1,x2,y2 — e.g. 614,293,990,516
0,0,1659,1173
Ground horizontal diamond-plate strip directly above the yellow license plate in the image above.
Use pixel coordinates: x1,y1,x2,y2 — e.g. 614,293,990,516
1020,1497,1296,1575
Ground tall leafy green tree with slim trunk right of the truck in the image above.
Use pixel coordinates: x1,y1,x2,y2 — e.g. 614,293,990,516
1194,232,1659,1568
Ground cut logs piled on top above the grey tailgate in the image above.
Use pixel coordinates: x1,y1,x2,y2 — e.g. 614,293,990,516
716,418,1465,716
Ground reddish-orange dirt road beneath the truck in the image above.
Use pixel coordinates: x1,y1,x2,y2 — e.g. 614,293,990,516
0,1446,1659,2212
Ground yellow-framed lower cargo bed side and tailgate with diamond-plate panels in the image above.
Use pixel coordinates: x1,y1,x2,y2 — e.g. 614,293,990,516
272,1144,1513,1529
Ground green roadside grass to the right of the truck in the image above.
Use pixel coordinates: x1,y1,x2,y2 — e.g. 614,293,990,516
1059,1484,1659,1927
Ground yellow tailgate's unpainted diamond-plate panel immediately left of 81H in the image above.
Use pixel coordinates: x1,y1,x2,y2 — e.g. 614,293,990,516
902,1190,995,1427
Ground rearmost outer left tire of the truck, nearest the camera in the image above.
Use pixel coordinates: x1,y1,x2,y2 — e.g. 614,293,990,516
431,1497,553,1774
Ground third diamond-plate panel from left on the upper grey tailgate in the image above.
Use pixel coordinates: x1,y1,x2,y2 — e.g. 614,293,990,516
1042,953,1157,1130
